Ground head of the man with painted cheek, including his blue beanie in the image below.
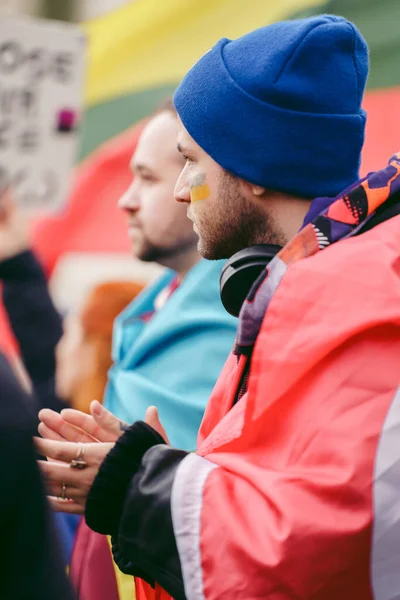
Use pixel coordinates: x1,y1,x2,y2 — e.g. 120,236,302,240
174,16,368,259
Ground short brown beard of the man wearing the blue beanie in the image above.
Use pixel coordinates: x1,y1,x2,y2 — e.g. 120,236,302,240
194,171,286,260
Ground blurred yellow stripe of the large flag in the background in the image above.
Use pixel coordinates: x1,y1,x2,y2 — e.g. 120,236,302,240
84,0,325,106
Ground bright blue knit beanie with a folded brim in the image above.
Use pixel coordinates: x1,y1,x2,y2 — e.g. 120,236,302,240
174,15,368,198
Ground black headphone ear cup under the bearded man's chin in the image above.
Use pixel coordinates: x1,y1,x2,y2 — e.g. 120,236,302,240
219,244,282,317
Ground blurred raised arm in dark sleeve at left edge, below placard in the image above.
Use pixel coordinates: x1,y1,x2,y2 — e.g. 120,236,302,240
0,192,66,410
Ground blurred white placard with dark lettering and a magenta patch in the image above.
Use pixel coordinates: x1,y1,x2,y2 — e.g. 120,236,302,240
0,17,86,212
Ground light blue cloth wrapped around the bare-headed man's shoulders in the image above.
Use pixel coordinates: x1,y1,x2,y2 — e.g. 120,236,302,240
104,260,237,450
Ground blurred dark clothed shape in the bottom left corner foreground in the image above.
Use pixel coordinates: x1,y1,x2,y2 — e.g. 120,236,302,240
0,355,73,600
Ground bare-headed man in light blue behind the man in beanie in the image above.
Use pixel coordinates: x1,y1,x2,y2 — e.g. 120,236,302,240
64,102,236,600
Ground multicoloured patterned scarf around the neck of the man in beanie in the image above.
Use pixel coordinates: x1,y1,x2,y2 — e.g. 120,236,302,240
235,153,400,355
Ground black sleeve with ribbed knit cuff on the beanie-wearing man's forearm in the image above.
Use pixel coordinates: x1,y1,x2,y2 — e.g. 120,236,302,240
85,434,189,600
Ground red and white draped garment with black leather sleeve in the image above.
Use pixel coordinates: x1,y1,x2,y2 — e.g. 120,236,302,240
87,209,400,600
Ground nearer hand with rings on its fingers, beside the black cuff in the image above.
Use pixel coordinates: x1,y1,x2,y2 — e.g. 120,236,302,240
35,438,114,514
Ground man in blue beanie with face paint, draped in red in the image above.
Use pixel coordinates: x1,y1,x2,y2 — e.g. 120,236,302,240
35,15,400,600
